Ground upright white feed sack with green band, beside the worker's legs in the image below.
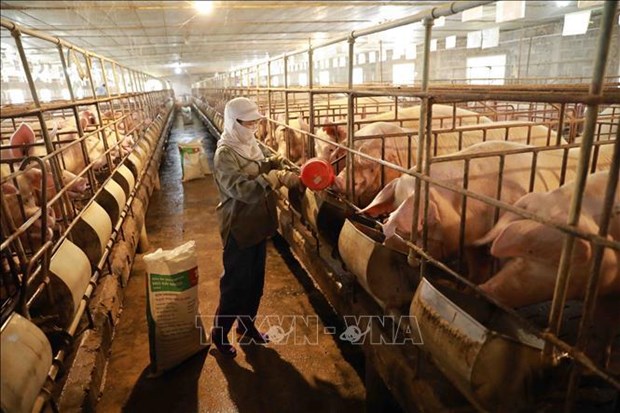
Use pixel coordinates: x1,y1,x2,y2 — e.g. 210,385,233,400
144,241,207,376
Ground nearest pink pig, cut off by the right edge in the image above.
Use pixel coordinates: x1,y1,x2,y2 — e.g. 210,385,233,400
476,172,620,307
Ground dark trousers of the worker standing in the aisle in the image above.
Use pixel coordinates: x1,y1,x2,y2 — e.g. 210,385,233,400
213,235,267,338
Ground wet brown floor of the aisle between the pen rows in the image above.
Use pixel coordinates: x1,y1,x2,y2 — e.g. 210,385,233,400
97,111,365,413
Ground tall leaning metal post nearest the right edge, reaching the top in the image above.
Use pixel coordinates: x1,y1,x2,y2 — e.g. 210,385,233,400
543,0,618,361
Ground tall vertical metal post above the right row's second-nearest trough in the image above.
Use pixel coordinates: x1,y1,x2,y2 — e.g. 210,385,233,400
407,18,433,265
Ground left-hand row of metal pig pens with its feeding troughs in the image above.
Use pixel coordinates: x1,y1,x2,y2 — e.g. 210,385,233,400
0,20,173,411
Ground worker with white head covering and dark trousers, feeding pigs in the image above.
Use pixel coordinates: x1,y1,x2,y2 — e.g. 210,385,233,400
211,98,302,357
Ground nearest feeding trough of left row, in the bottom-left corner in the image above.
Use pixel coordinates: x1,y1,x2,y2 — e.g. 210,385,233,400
0,313,52,412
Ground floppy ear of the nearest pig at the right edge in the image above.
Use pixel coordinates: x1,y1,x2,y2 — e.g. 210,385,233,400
491,220,592,263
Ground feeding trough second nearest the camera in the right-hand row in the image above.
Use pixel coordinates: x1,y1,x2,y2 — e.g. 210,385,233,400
338,219,417,309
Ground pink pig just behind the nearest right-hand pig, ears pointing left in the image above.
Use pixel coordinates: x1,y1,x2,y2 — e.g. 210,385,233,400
364,141,574,281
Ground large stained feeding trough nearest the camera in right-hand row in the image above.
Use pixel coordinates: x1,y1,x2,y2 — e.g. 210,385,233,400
410,278,544,411
